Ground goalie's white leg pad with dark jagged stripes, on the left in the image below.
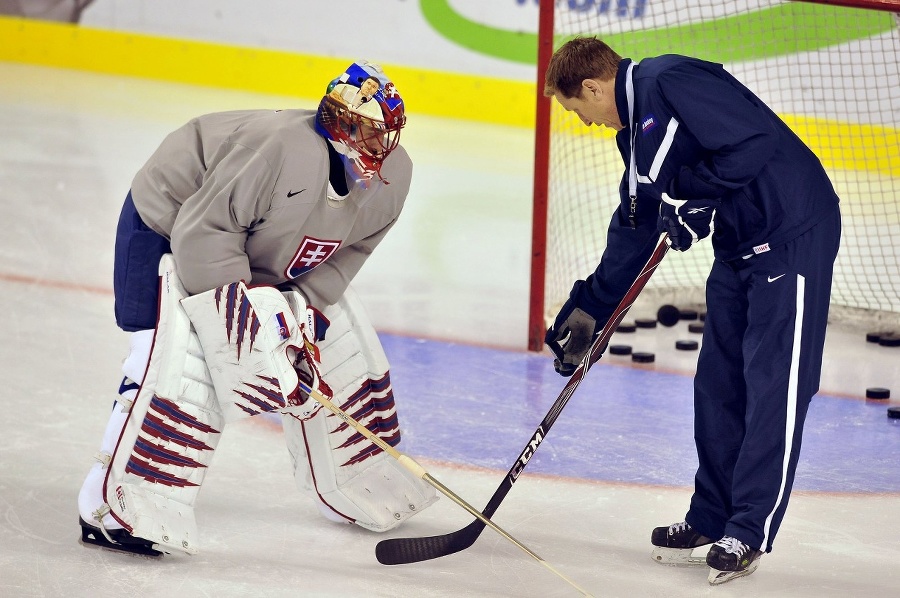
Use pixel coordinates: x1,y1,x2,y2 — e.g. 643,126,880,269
103,255,224,553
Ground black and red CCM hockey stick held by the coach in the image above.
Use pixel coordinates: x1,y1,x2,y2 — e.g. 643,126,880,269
375,233,669,565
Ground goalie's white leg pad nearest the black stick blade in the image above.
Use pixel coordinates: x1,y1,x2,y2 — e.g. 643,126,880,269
282,289,437,532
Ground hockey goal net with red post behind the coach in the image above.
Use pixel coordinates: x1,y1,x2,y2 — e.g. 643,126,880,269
529,0,900,350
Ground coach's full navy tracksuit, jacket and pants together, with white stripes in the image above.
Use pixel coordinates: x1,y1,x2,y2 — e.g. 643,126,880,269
583,55,840,551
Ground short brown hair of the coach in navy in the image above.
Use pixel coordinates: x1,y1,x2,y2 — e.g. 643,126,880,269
544,37,622,98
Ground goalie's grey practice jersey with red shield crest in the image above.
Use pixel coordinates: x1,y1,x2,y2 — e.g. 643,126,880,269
132,110,412,309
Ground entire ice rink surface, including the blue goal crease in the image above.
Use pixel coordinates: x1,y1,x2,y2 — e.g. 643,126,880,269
0,64,900,598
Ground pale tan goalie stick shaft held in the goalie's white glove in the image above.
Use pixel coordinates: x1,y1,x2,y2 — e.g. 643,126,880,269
299,381,591,596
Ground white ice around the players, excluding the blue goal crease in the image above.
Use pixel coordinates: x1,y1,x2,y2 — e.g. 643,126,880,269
0,64,900,598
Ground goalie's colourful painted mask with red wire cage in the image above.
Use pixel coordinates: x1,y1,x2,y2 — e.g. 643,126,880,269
316,61,406,183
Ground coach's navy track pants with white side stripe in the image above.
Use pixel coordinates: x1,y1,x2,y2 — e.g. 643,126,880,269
686,207,841,552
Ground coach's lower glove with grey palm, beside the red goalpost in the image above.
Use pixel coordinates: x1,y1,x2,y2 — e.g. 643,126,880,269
544,280,612,377
